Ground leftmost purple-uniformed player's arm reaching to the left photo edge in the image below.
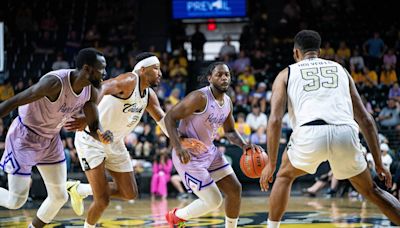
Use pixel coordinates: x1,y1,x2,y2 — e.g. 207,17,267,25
0,75,62,117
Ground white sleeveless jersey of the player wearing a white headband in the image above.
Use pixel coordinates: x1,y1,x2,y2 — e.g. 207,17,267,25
86,73,150,142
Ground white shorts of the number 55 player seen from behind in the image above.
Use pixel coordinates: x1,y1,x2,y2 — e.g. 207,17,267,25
287,125,367,180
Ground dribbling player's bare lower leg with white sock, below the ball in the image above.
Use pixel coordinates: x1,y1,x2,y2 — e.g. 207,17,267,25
217,173,242,228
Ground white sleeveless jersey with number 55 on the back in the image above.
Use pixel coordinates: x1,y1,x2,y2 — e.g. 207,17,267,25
287,58,358,131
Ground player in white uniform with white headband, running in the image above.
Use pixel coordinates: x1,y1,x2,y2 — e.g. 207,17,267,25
64,52,181,227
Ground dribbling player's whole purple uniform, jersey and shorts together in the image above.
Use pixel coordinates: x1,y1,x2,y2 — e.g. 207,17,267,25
172,86,233,190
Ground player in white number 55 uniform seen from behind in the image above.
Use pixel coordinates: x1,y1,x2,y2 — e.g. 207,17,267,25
260,30,400,228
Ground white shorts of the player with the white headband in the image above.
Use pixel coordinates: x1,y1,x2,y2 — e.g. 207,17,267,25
75,131,133,173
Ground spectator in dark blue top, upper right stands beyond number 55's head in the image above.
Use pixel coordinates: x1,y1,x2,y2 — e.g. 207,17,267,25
363,32,385,70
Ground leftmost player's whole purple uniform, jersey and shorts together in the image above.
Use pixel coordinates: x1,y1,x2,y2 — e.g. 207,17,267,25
0,70,91,175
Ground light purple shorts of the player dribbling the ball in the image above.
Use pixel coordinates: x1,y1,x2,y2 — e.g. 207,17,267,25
172,147,234,191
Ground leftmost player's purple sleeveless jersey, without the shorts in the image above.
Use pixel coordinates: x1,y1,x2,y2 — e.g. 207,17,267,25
18,69,90,139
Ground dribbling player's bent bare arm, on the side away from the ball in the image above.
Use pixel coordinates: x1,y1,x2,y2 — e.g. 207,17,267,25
165,91,207,164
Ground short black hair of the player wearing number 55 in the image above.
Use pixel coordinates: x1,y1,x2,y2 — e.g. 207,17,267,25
294,30,321,53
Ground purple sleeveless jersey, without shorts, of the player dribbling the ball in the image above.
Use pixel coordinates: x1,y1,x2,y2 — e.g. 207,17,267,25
178,86,231,150
